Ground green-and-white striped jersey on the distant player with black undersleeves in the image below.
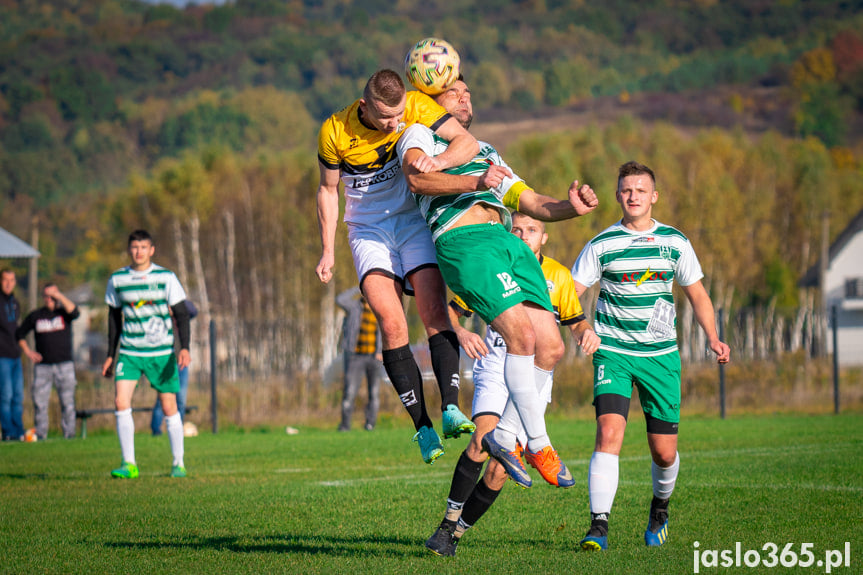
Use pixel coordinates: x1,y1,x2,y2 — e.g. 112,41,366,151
105,264,186,357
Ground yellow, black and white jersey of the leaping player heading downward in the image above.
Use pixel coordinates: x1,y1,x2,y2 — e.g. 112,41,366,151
318,91,451,223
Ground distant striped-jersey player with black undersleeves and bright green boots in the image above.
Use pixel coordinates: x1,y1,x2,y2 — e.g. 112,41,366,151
102,230,192,479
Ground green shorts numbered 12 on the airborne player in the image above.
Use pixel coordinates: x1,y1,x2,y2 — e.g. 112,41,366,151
435,224,554,324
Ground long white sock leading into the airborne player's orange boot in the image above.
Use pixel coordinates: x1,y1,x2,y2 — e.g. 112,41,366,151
502,353,551,452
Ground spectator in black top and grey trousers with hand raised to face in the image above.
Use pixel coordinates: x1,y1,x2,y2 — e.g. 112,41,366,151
15,284,81,440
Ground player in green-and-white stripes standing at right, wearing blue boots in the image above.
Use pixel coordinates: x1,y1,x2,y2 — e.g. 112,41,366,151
572,162,730,550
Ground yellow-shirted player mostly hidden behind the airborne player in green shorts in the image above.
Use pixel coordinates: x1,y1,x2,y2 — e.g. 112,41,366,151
426,212,600,556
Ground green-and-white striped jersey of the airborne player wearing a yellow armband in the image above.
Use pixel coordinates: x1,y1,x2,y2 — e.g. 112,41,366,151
398,124,528,241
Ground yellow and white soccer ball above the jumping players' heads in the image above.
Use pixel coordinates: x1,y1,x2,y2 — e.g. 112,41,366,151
405,38,461,96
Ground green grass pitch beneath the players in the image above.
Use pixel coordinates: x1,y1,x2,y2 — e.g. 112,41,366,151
0,414,863,575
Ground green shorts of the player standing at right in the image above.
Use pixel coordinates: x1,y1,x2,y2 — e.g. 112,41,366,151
593,349,680,423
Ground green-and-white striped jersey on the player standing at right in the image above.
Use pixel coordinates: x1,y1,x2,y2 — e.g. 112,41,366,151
572,221,704,357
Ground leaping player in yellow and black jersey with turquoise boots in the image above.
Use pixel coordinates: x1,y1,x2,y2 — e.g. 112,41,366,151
315,70,479,463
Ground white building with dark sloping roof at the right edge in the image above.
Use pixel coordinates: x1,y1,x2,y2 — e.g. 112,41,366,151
800,210,863,366
